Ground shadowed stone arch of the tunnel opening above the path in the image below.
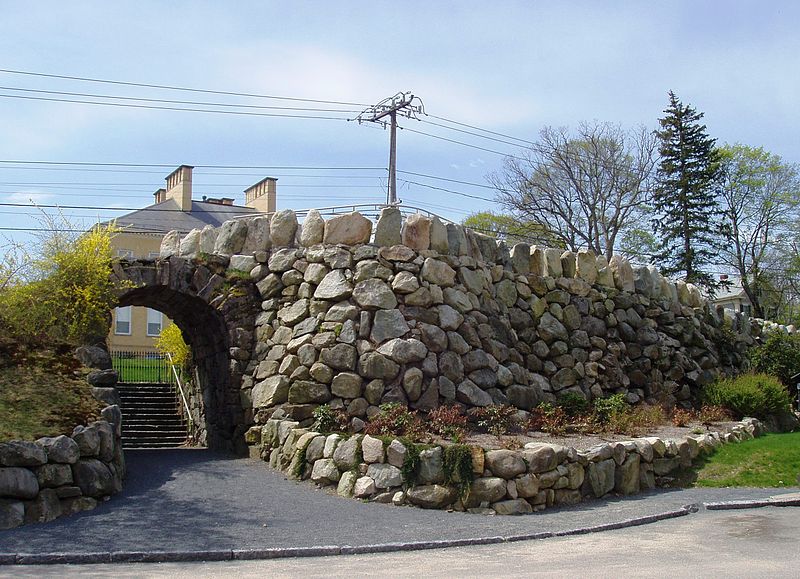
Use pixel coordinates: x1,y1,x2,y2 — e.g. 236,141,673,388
112,257,259,453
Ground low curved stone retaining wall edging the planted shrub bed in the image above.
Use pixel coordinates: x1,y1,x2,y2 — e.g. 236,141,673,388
252,418,762,515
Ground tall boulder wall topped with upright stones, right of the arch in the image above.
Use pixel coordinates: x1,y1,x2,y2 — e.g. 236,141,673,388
162,207,794,440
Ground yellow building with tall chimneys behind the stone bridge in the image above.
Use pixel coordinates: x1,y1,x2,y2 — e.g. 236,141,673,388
108,165,277,351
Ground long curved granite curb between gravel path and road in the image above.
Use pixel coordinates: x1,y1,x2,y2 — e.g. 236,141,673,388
0,499,700,566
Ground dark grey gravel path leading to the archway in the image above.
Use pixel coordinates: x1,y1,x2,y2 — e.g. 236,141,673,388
0,449,781,557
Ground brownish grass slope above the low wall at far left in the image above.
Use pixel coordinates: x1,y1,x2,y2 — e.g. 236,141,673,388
0,344,102,442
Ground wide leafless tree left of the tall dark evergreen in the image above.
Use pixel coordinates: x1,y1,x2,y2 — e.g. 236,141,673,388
489,123,656,258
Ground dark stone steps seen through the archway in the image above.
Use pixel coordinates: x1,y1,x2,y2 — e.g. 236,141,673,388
117,383,187,448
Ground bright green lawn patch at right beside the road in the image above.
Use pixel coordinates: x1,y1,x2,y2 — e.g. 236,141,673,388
685,432,800,488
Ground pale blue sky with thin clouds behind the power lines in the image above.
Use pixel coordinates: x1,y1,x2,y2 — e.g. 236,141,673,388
0,0,800,247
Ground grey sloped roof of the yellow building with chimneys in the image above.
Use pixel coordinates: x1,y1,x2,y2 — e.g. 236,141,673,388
116,199,258,235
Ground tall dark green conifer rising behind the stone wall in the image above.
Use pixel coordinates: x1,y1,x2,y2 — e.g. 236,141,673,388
653,91,722,296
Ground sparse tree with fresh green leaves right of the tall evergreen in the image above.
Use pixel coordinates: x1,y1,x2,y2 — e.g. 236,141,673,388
720,144,800,318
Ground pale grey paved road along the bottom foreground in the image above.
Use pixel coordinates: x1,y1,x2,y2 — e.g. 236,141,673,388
0,507,800,579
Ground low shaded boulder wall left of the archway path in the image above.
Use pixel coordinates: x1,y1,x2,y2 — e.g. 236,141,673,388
0,405,125,529
